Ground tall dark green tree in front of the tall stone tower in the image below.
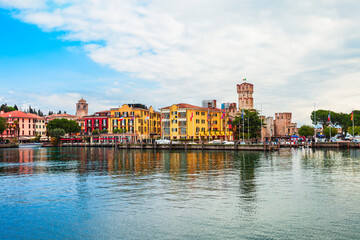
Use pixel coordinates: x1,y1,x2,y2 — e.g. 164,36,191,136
232,109,262,138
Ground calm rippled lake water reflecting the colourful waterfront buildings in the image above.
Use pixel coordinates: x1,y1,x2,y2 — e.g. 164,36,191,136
0,148,360,239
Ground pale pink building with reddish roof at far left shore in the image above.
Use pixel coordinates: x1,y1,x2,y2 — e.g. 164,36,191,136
0,111,37,140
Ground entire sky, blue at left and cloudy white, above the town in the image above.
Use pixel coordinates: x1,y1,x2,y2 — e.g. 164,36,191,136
0,0,360,125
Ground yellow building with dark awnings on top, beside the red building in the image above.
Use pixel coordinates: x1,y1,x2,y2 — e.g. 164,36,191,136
108,104,161,141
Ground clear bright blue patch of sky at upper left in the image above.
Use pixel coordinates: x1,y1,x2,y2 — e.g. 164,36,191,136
0,9,153,113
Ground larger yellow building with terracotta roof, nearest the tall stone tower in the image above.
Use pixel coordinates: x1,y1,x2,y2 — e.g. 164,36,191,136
161,103,233,140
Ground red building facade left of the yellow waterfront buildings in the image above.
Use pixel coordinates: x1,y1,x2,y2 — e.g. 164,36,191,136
84,111,110,135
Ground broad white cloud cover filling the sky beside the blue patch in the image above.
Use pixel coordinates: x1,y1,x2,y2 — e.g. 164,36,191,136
0,0,360,122
